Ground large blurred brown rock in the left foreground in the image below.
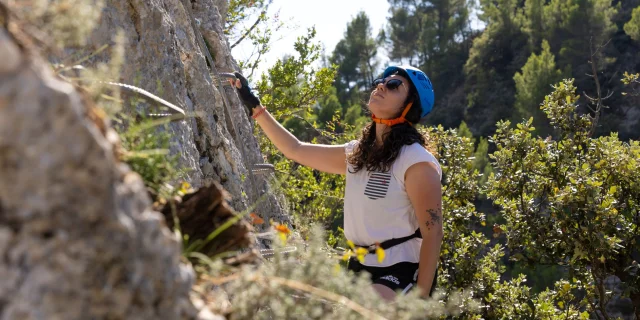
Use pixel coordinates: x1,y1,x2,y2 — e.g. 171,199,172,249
0,27,202,319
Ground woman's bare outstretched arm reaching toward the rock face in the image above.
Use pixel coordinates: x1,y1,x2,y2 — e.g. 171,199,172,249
253,106,347,174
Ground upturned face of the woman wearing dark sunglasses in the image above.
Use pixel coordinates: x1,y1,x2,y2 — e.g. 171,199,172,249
369,75,409,119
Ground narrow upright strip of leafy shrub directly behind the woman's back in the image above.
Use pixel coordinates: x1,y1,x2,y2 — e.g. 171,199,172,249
427,127,496,297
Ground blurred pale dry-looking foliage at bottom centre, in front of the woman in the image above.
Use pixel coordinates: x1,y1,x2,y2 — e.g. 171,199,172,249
200,228,477,319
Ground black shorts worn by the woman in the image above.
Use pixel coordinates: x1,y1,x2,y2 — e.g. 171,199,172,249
347,258,437,295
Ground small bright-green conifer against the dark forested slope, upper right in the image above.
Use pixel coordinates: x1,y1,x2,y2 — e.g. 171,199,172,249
513,40,562,136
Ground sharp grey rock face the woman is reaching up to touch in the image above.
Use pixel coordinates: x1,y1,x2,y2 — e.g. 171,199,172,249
83,0,288,225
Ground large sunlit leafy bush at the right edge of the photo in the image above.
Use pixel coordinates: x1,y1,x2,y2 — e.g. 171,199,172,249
488,81,640,314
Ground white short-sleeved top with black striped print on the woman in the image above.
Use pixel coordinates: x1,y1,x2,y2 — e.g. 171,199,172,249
344,140,442,267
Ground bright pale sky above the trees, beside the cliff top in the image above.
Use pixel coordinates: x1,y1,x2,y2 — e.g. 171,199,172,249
232,0,389,74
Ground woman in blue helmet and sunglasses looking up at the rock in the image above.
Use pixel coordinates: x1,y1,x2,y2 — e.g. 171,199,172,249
232,66,443,301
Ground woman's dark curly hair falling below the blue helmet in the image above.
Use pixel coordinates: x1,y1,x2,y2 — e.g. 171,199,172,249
347,70,435,173
